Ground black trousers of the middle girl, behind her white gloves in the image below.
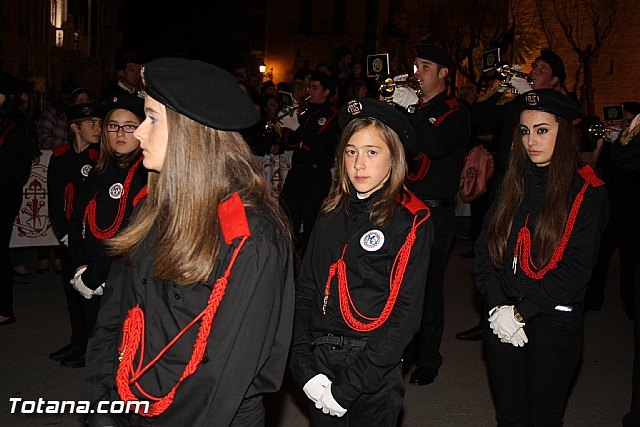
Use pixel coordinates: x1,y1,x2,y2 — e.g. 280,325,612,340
309,344,405,427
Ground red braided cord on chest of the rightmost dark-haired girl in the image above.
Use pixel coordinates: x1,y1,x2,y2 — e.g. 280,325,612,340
513,181,591,280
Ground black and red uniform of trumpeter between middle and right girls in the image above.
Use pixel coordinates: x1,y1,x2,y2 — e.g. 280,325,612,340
403,92,470,377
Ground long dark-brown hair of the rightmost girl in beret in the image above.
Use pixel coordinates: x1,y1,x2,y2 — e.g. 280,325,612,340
487,116,580,267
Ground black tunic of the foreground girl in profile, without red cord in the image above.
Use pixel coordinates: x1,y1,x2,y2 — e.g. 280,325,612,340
83,198,295,427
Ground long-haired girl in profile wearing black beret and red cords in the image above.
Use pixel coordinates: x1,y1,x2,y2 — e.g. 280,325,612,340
83,58,294,426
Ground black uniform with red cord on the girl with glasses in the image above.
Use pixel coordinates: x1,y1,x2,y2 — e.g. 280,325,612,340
69,155,147,333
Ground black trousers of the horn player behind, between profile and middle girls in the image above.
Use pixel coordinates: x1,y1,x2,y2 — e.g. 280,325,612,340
282,165,331,254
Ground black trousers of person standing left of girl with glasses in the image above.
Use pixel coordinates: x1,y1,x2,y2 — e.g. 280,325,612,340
58,245,88,347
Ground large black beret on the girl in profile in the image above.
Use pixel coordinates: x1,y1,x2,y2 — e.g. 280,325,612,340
142,58,260,130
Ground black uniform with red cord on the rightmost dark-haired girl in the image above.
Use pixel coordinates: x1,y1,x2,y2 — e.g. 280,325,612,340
474,162,609,425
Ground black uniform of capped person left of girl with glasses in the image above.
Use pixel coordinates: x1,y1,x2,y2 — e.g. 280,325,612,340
47,143,100,349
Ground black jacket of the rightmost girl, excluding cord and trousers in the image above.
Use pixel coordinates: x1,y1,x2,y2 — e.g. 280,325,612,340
474,163,609,322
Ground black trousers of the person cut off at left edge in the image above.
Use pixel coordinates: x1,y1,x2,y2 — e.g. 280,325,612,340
0,185,22,317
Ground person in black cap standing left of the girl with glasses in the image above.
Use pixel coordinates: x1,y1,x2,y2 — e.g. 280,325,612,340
47,104,104,367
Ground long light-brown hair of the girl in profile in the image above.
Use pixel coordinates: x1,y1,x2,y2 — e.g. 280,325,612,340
109,108,290,285
